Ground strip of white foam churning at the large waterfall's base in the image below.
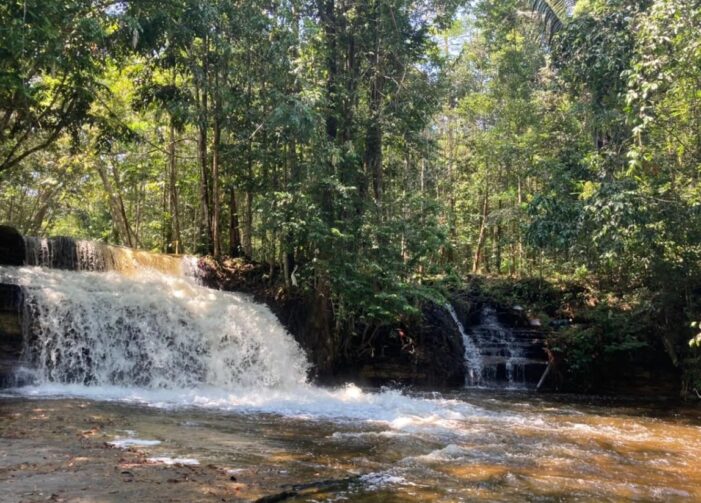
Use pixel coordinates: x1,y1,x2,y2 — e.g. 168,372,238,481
9,384,492,433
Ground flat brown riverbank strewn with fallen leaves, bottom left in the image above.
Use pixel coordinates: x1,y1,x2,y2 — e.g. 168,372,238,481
0,399,264,502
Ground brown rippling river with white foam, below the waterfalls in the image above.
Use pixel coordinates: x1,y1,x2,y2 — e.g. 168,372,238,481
0,386,701,502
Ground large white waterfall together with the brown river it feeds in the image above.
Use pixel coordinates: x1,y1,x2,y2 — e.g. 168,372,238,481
0,266,701,502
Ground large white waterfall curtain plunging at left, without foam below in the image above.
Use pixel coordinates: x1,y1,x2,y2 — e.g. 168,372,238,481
0,268,308,389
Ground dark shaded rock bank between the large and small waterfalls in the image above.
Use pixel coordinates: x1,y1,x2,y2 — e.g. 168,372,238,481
191,259,465,386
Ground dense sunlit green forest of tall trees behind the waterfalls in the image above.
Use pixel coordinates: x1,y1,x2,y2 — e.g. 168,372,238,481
0,0,701,391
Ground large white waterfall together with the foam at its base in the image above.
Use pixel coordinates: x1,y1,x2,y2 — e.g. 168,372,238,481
0,267,508,440
